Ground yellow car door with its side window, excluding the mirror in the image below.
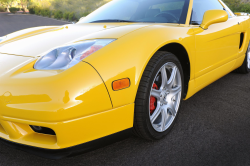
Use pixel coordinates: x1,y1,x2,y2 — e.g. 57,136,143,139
191,0,243,88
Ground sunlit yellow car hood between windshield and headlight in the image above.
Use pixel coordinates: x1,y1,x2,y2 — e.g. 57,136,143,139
0,23,149,57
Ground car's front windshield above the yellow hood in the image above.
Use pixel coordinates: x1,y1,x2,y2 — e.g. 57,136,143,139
79,0,189,24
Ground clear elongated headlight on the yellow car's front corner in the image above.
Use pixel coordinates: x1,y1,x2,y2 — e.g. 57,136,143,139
34,39,115,70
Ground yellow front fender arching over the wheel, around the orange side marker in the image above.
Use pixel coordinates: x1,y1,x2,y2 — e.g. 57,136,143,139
84,24,195,108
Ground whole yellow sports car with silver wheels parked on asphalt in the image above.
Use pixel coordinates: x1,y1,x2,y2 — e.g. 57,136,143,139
0,0,250,158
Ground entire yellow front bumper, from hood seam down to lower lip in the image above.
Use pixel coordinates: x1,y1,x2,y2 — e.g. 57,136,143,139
0,54,134,154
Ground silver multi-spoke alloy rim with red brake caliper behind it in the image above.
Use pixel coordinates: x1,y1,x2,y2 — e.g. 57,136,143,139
149,62,182,132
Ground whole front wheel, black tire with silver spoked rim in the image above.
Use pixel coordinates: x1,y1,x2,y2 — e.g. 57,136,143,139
134,51,184,140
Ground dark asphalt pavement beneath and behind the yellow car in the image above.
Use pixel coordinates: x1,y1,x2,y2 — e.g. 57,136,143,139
0,13,250,166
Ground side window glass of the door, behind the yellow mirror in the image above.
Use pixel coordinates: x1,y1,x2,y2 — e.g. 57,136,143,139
191,0,231,25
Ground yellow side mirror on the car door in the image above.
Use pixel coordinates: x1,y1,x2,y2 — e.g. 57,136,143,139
200,10,228,30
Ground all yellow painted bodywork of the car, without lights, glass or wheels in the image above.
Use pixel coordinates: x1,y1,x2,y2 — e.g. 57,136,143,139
0,0,250,149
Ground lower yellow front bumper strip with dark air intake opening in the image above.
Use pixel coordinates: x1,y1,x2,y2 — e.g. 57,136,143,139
0,104,134,149
